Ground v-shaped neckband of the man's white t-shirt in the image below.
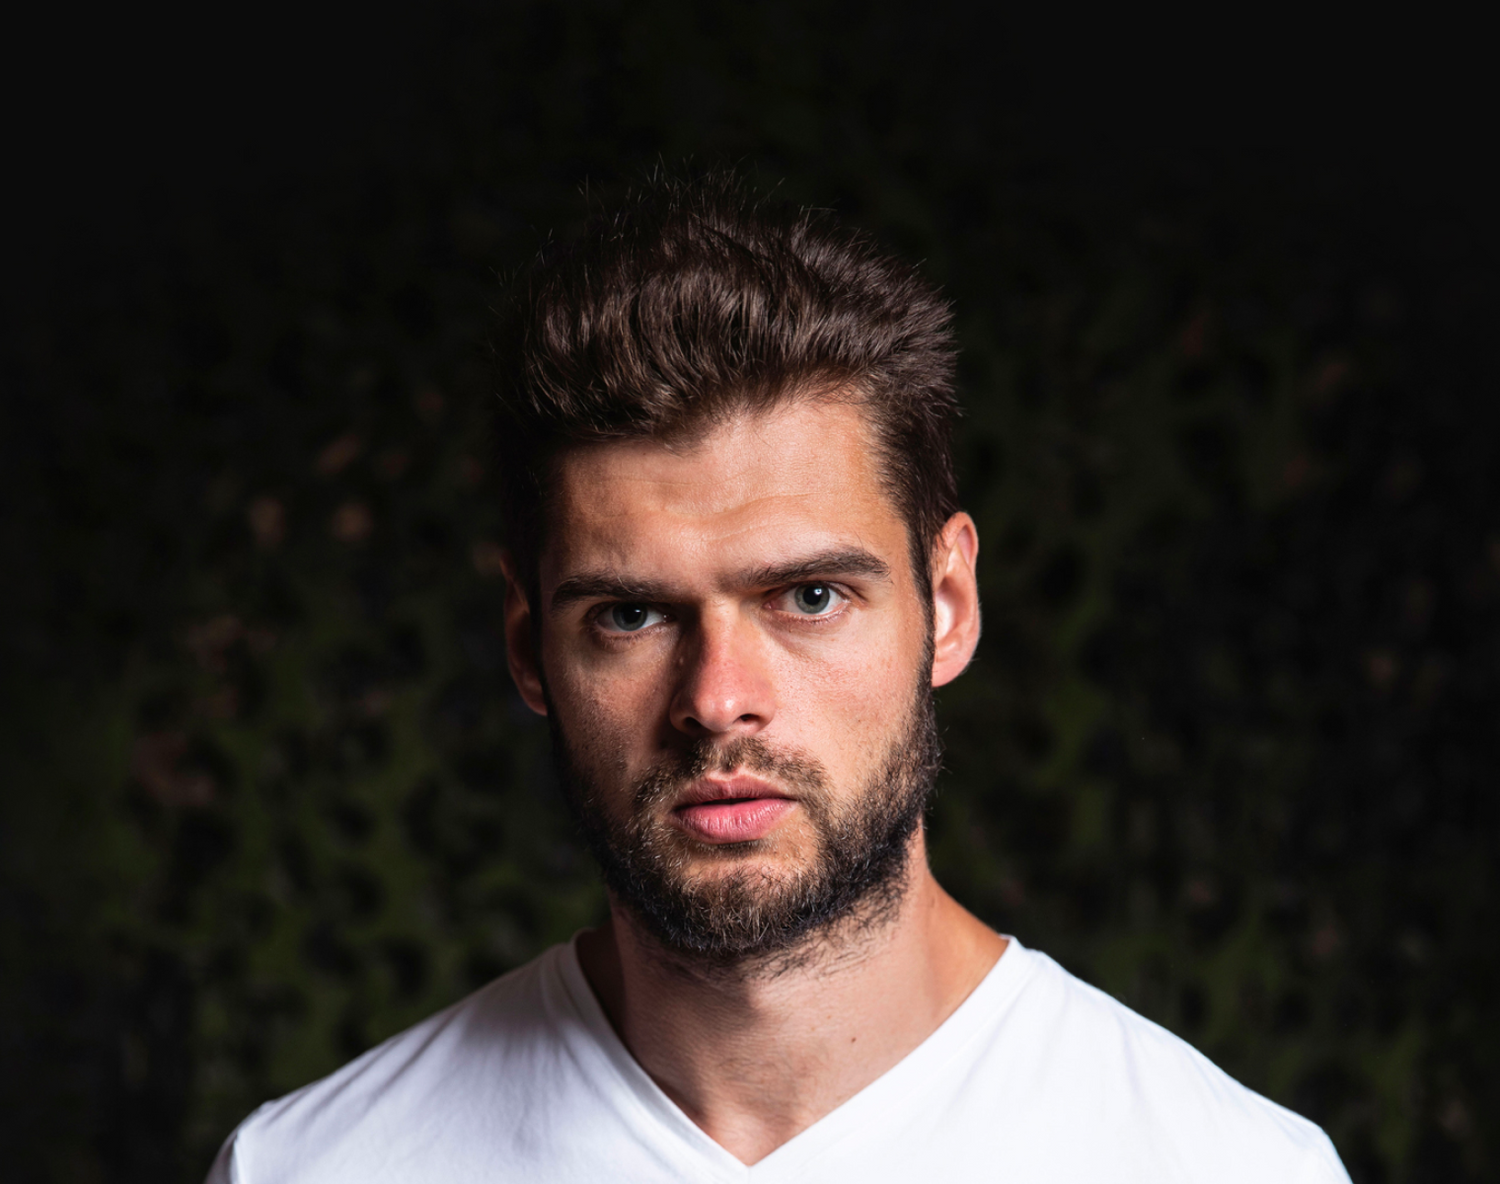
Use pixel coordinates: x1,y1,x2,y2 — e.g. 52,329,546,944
549,935,1035,1184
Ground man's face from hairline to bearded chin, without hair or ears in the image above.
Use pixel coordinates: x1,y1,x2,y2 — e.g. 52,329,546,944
518,399,938,959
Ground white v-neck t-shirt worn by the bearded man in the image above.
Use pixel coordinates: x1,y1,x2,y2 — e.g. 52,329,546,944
209,938,1349,1184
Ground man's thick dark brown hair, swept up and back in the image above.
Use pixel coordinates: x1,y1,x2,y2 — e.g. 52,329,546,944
495,174,959,603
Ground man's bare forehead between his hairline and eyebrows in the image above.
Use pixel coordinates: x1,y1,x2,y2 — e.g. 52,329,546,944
542,399,906,582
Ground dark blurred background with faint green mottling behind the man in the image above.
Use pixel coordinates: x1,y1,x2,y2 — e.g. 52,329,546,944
0,0,1500,1181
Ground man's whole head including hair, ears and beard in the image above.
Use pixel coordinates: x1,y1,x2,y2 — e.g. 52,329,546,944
503,177,978,962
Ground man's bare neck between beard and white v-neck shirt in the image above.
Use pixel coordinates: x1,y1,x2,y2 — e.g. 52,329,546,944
578,830,1005,1163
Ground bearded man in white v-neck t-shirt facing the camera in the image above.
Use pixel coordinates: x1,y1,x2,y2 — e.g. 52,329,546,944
215,182,1347,1184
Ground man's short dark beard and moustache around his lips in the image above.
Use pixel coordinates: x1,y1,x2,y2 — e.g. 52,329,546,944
548,683,942,969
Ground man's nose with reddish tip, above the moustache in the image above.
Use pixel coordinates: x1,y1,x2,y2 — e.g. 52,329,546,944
671,612,776,738
